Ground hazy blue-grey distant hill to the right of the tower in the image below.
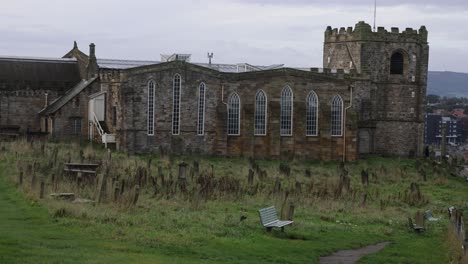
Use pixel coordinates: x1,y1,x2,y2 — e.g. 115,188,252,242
427,71,468,97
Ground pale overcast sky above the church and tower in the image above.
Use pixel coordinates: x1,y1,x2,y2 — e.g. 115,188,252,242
0,0,468,72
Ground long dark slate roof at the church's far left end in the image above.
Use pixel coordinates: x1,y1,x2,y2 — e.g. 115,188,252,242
0,56,80,90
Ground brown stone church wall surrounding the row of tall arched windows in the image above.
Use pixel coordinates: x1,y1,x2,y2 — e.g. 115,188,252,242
115,62,357,160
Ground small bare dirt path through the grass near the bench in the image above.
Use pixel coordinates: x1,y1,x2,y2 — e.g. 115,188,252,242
319,242,390,264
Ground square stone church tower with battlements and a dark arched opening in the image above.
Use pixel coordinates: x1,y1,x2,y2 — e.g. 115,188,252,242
323,21,429,156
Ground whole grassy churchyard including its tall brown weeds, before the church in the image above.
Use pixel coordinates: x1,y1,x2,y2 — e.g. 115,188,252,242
0,141,468,263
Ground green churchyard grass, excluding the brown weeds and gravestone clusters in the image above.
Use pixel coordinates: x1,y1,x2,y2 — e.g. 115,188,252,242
0,139,468,263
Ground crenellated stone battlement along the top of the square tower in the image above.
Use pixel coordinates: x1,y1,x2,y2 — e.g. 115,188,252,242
325,21,428,44
